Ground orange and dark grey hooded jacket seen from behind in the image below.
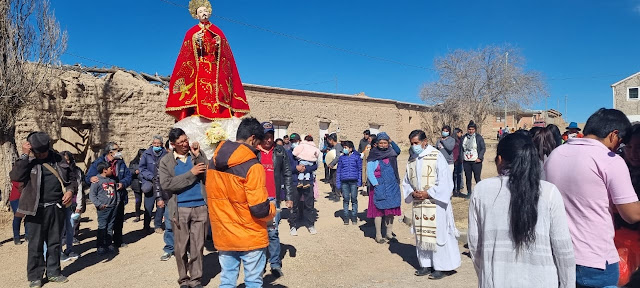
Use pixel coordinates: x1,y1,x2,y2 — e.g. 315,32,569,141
206,141,276,251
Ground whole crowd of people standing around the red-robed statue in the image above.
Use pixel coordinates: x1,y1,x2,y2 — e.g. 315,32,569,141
10,109,640,288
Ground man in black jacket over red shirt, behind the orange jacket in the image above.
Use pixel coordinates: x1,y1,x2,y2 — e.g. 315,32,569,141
258,122,293,277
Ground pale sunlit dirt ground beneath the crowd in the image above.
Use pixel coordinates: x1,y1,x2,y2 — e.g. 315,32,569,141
0,144,496,288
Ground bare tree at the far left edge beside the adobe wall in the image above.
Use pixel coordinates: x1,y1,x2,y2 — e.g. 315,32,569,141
0,0,67,208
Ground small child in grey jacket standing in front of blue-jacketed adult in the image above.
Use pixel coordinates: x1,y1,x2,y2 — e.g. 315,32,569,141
89,162,118,255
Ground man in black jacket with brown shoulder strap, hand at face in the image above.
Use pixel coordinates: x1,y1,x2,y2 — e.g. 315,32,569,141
9,132,77,287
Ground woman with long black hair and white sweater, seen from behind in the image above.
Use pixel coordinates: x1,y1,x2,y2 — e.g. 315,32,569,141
468,133,576,287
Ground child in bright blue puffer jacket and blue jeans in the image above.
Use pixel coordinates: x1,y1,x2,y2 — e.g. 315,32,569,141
336,141,362,225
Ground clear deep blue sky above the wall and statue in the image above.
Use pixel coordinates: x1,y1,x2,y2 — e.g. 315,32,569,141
52,0,640,122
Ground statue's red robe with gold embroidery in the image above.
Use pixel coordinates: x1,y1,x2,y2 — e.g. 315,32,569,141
166,23,249,121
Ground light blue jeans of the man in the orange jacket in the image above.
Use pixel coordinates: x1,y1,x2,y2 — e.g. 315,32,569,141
218,249,267,288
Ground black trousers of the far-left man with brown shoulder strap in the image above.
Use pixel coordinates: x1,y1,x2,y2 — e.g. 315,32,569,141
24,205,64,281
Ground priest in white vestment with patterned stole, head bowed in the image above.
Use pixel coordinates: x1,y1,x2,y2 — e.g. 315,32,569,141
402,130,461,279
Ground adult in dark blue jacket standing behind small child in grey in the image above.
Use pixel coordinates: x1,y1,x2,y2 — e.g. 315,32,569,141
84,142,131,249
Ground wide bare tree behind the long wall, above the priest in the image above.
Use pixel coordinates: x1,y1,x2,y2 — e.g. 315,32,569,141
421,46,547,134
